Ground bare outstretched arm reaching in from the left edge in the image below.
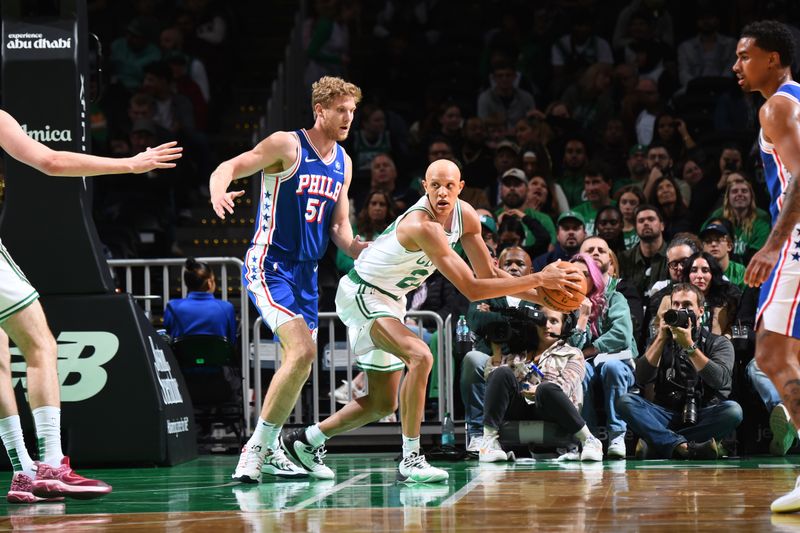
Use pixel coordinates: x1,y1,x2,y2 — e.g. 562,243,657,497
0,110,183,177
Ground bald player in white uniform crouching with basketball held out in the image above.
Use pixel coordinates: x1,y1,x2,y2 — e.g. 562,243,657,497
283,159,582,483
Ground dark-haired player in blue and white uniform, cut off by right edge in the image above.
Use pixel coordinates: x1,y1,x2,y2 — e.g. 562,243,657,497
733,21,800,512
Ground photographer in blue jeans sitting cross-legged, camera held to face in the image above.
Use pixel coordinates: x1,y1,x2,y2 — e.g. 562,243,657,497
616,283,742,459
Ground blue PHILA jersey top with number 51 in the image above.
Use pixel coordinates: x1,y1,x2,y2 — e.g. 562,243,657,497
251,129,345,261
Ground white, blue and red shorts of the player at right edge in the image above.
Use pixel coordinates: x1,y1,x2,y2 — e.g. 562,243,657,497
756,234,800,339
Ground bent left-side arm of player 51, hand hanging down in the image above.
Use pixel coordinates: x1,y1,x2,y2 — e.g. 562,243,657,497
208,131,299,220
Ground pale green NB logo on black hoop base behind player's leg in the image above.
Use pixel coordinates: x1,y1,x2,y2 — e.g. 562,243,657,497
11,331,119,402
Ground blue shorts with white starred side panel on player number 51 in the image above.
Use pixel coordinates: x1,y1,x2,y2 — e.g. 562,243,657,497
242,249,319,340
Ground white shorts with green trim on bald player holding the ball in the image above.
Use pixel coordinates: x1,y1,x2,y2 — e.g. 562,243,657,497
336,276,406,372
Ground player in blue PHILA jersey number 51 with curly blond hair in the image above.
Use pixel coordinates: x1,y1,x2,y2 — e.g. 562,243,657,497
209,76,366,483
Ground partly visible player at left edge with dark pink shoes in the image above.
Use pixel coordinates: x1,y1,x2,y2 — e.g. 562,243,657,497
0,111,182,503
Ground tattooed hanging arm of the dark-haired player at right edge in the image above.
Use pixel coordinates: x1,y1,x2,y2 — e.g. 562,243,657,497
744,97,800,287
